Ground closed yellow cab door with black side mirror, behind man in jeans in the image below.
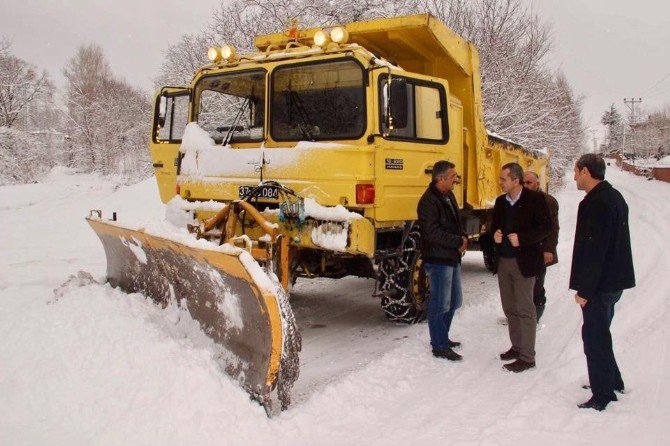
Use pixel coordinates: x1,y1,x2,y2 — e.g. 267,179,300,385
375,70,463,222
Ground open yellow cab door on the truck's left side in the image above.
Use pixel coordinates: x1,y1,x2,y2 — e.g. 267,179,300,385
149,87,191,203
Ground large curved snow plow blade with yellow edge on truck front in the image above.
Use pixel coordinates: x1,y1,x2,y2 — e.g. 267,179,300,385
87,218,300,415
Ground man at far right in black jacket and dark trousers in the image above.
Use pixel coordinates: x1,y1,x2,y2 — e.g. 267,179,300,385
570,153,635,410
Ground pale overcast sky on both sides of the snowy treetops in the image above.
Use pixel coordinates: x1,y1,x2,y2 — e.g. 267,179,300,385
0,0,670,143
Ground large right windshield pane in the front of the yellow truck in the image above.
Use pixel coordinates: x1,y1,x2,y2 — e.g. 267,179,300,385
270,59,366,141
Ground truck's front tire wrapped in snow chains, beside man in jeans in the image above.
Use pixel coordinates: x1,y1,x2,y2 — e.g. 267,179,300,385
379,226,428,324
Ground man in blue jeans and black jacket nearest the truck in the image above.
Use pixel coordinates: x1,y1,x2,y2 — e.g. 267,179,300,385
417,161,468,361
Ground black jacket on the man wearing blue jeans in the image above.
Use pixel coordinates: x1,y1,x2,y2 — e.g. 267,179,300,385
416,183,465,265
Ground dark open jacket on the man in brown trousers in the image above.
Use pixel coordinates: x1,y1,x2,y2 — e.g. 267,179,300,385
489,187,551,277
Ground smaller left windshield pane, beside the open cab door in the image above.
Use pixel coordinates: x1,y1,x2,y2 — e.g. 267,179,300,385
195,70,265,144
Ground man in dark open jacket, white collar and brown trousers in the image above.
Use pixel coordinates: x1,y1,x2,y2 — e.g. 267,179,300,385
490,163,551,373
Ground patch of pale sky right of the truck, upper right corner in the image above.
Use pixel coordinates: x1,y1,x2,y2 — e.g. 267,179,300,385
525,0,670,145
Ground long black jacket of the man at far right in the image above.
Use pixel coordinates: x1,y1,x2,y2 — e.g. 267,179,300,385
570,181,635,299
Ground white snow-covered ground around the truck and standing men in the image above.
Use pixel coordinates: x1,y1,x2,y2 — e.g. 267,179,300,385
0,165,670,446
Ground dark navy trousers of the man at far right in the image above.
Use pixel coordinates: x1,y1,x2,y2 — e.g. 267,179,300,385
582,291,623,402
